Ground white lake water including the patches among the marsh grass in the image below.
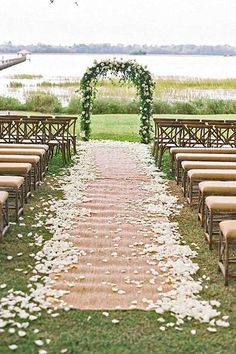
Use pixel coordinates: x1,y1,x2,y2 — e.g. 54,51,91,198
0,54,236,104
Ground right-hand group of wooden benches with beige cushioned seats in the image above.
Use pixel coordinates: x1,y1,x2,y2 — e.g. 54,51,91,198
170,147,236,285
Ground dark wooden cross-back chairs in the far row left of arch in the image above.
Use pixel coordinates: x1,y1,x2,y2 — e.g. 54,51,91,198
0,115,77,162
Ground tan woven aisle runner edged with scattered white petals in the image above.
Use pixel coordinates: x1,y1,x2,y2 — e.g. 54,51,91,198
52,144,169,309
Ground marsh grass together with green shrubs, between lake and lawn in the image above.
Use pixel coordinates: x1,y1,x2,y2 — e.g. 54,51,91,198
0,74,236,114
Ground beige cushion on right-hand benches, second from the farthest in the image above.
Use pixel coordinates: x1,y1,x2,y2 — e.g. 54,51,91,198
176,154,236,162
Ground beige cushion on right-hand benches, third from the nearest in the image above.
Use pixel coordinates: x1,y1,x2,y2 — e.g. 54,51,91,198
199,181,236,195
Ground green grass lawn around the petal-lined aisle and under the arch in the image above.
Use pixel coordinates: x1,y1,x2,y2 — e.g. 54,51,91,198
0,115,236,354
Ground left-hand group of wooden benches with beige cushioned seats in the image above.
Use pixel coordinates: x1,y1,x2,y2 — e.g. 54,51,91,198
0,144,49,238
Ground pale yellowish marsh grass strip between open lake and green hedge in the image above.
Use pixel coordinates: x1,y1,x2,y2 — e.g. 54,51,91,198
0,74,236,106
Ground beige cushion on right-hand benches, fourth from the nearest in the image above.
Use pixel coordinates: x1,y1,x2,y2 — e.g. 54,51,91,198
188,169,236,181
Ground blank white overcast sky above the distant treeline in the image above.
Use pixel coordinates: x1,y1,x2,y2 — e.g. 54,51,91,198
0,0,236,46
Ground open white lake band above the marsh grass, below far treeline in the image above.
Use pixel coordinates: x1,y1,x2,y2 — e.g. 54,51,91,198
0,54,236,78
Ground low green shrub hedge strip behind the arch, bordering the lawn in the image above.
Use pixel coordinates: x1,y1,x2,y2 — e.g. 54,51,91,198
0,91,236,114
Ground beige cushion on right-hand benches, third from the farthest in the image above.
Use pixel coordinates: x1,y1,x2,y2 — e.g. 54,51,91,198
181,161,236,170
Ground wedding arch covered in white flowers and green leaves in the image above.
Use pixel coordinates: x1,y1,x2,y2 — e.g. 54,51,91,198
80,59,154,144
